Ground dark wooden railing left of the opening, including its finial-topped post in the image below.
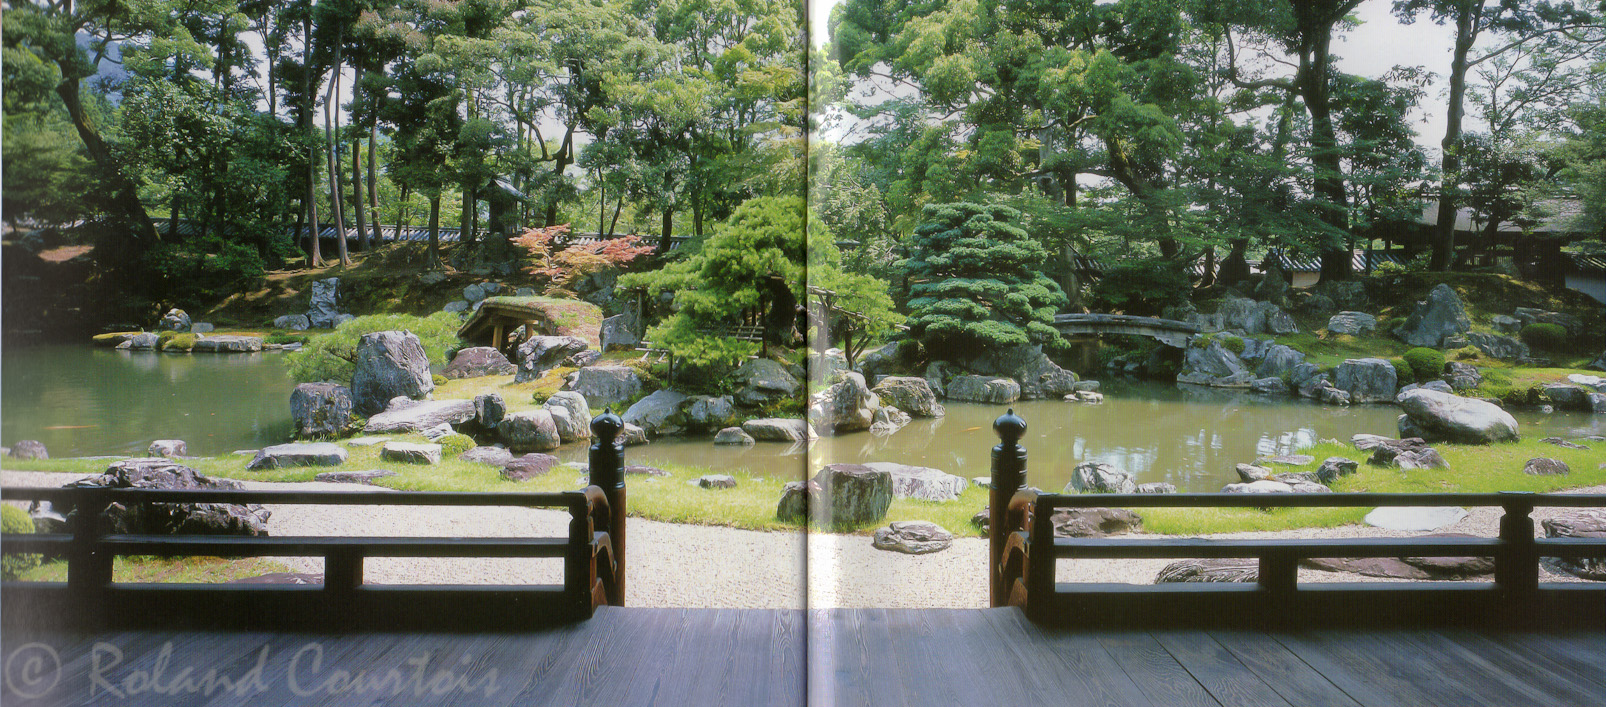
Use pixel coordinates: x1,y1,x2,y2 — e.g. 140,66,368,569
0,411,626,630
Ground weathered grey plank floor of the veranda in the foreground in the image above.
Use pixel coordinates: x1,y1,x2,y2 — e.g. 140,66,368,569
0,607,1606,707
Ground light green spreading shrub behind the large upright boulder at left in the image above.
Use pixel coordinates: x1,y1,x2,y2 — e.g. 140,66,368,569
286,312,461,382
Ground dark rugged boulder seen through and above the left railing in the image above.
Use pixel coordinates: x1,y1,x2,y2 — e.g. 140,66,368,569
67,458,270,537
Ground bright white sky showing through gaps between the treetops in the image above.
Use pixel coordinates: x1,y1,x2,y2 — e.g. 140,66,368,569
809,0,1471,153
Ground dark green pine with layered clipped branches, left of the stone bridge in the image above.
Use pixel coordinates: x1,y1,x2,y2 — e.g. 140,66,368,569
903,202,1065,358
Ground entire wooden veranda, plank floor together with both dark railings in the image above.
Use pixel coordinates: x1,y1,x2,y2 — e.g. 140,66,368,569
0,413,1606,707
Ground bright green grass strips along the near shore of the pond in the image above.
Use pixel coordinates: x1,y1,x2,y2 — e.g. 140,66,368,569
6,435,1606,537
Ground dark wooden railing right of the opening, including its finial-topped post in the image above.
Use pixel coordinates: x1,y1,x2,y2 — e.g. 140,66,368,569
989,411,1606,628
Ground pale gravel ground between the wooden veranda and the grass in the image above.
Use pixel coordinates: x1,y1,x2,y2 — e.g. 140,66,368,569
0,471,1606,609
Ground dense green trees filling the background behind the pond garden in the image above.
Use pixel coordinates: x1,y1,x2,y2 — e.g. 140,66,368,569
3,0,1606,326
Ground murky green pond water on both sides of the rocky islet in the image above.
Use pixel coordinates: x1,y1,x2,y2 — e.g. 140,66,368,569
0,345,1606,492
